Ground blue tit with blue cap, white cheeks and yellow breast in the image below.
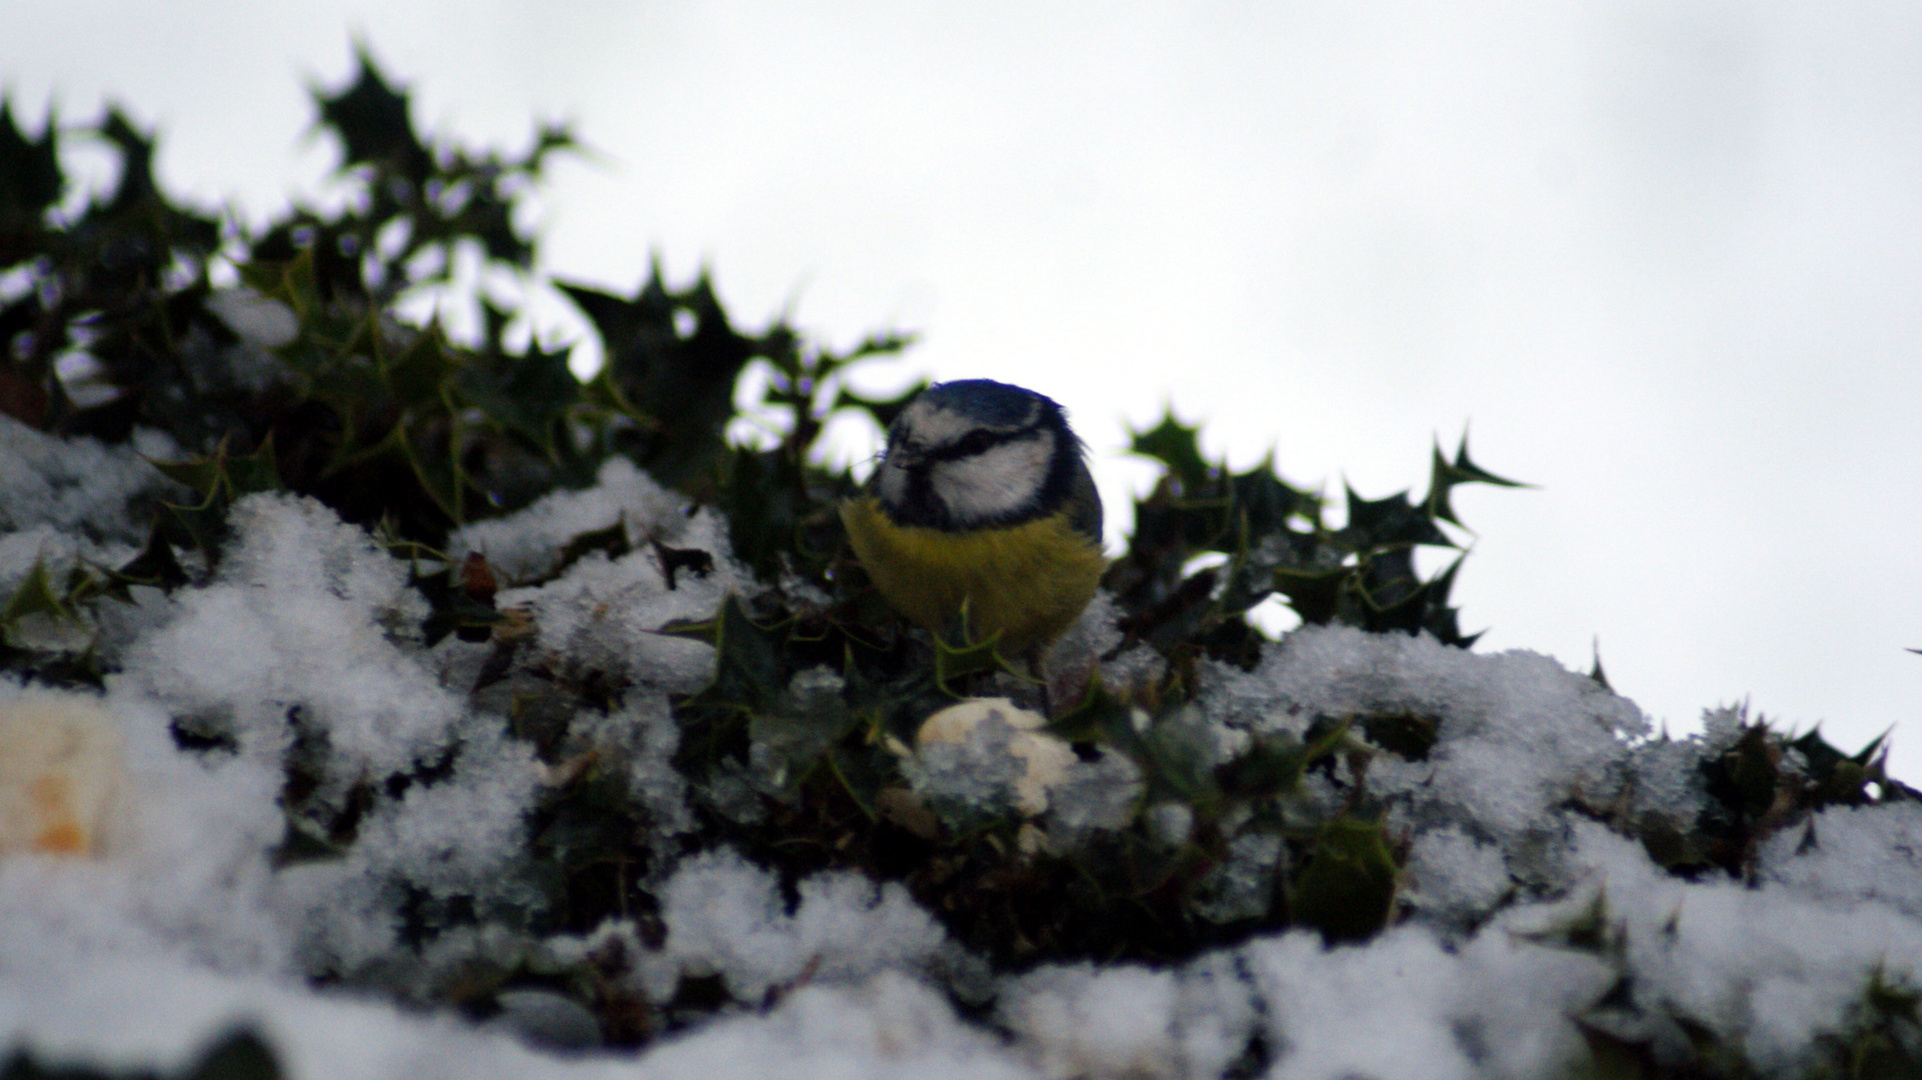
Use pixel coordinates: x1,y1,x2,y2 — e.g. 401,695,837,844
840,379,1107,655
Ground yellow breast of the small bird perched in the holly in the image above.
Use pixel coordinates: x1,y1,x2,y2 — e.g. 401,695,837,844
840,498,1107,655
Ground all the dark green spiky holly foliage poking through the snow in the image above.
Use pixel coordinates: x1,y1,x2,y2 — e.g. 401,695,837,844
33,46,1891,1078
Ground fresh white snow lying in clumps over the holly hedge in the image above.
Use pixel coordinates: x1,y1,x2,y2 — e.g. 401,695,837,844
0,419,1922,1080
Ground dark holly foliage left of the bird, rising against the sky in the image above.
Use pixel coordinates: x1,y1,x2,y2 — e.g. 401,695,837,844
0,45,903,549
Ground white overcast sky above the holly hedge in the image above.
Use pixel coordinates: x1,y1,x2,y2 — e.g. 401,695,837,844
11,0,1922,772
